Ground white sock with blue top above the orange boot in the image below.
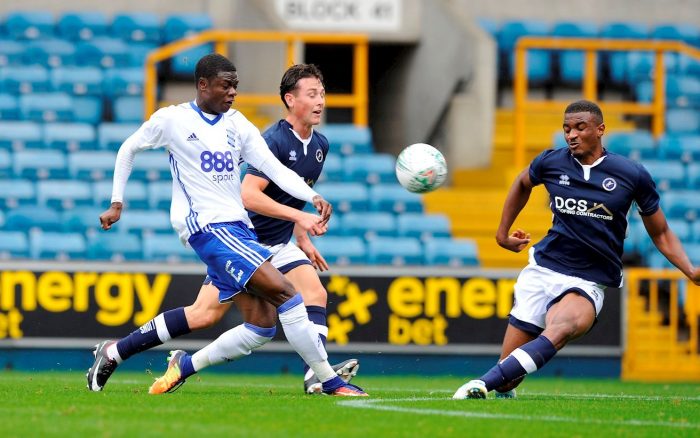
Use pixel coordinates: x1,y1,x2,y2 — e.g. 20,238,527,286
192,323,275,371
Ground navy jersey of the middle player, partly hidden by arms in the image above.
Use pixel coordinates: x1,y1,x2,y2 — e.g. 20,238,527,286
248,120,328,245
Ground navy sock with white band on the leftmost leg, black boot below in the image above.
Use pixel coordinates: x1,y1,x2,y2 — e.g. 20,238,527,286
117,307,190,360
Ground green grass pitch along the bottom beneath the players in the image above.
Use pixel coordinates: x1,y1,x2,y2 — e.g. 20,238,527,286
0,371,700,438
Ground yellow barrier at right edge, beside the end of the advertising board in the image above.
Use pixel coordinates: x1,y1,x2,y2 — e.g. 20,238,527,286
622,269,700,382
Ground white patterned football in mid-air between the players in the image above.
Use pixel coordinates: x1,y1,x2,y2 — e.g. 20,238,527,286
396,143,447,193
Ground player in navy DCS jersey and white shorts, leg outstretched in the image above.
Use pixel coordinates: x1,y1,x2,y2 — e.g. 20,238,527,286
453,100,700,399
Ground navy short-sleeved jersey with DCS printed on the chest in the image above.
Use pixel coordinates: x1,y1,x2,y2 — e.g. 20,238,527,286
530,148,659,287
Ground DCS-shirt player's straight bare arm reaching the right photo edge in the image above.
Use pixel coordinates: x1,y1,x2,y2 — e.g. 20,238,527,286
642,208,700,284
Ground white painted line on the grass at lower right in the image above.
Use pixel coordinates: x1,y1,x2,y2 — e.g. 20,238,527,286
338,397,700,429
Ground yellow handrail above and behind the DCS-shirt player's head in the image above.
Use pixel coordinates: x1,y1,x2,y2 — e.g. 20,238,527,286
513,37,700,169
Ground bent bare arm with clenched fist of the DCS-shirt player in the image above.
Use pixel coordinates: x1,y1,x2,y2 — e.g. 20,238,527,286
496,168,534,252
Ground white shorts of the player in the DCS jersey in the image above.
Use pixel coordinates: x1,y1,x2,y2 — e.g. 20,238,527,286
509,251,605,334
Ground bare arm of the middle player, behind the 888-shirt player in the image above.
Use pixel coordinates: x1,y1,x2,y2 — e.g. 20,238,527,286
241,173,327,236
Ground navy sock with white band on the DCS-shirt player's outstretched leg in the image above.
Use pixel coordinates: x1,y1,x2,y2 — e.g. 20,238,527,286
479,335,557,391
